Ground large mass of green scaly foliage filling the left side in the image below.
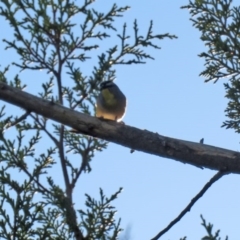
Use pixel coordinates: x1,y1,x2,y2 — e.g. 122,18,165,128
0,0,176,240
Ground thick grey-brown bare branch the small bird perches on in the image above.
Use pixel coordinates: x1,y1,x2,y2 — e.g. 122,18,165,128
0,82,240,173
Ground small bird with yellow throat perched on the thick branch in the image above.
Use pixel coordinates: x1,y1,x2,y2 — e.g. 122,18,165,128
96,81,127,122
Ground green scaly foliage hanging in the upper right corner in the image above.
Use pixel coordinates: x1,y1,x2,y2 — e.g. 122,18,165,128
183,0,240,133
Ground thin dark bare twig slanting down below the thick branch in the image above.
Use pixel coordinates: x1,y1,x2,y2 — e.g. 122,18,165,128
151,171,230,240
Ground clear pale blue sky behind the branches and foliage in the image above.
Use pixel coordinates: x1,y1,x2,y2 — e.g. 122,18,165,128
0,0,240,240
